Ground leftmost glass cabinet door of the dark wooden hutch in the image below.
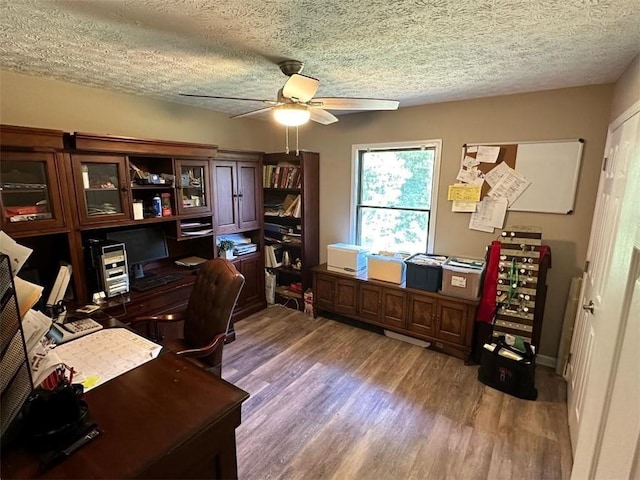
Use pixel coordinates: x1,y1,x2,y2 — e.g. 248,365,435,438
0,152,64,231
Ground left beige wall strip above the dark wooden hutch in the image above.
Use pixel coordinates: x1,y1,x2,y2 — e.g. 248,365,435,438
0,71,267,150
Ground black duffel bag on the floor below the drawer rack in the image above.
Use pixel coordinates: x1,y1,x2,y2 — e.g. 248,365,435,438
478,337,538,400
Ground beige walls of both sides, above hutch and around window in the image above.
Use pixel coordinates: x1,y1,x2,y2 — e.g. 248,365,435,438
0,67,613,356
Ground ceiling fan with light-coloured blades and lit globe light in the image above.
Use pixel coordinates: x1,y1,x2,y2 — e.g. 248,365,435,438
180,60,399,127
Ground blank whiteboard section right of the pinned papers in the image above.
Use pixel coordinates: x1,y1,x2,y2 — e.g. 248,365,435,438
474,139,584,214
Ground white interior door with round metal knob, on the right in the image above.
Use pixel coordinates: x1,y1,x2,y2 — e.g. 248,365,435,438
567,104,640,478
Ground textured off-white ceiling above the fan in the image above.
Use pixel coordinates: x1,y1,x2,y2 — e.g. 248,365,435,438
0,0,640,120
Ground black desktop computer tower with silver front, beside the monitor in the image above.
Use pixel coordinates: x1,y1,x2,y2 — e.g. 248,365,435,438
89,239,129,298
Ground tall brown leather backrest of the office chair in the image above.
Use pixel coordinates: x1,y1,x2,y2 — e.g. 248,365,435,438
184,258,244,366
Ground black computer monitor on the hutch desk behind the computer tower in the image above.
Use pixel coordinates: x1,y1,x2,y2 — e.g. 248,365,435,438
107,227,169,278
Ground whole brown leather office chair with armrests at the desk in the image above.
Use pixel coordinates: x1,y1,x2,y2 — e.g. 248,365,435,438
133,258,244,376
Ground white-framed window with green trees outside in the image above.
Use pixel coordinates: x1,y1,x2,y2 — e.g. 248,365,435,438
352,141,440,253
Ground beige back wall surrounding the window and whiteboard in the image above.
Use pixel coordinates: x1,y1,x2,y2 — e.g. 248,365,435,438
298,85,613,357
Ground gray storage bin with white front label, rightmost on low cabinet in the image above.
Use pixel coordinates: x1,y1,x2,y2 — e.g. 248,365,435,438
440,257,485,300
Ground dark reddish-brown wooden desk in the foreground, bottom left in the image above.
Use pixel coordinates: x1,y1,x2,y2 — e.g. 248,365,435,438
1,352,249,479
